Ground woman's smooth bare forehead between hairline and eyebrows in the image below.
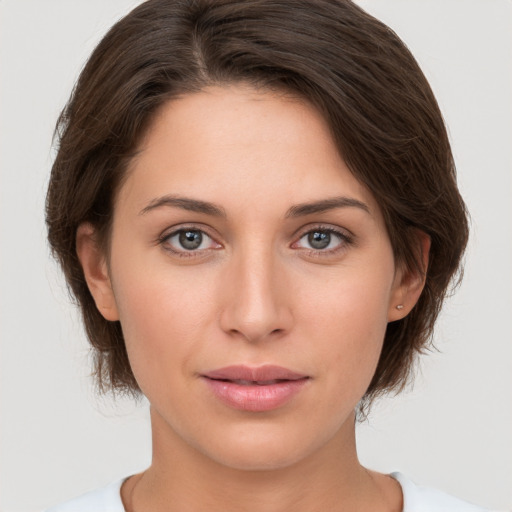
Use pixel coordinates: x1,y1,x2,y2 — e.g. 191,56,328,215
120,85,377,217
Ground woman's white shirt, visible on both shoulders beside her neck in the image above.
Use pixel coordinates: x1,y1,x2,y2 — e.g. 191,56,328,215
46,473,491,512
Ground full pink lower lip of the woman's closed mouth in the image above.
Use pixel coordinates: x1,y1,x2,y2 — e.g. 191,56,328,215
204,377,308,412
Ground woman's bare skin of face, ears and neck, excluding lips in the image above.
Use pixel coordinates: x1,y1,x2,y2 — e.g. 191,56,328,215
77,85,428,512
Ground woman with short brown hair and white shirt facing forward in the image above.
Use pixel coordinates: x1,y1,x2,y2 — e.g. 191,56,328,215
43,0,482,512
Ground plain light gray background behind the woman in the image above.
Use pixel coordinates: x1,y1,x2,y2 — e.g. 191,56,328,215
0,0,512,512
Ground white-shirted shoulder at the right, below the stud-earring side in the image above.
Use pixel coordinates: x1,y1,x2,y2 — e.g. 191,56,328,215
391,473,491,512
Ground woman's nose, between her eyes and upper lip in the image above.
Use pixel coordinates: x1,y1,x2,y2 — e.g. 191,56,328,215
220,245,293,342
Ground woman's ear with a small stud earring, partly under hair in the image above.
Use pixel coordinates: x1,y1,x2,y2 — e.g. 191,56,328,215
388,229,430,322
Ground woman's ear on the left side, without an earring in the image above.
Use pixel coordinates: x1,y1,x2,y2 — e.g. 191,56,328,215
76,223,119,322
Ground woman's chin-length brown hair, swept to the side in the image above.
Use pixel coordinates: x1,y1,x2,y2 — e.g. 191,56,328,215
46,0,468,408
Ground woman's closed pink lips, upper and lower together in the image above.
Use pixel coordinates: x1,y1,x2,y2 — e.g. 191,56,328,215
202,365,309,412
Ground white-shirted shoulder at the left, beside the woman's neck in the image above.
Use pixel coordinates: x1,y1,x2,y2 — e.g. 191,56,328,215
45,478,125,512
